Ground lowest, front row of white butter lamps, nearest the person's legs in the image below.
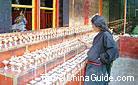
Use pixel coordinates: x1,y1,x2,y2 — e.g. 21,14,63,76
27,50,87,85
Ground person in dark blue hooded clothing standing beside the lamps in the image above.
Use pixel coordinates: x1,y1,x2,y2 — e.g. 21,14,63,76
80,15,119,85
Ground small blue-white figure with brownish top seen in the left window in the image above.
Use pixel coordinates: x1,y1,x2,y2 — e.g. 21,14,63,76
12,11,27,32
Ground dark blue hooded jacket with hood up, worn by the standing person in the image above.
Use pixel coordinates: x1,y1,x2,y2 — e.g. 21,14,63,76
87,15,119,64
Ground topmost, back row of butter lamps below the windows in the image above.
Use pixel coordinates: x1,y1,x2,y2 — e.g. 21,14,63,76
0,26,91,50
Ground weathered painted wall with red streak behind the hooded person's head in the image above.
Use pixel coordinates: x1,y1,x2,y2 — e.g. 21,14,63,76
69,0,99,26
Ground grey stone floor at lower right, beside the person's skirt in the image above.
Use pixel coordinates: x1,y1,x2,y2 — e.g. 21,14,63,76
109,58,138,85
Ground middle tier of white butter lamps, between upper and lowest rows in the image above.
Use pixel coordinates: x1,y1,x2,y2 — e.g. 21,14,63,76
3,39,84,72
